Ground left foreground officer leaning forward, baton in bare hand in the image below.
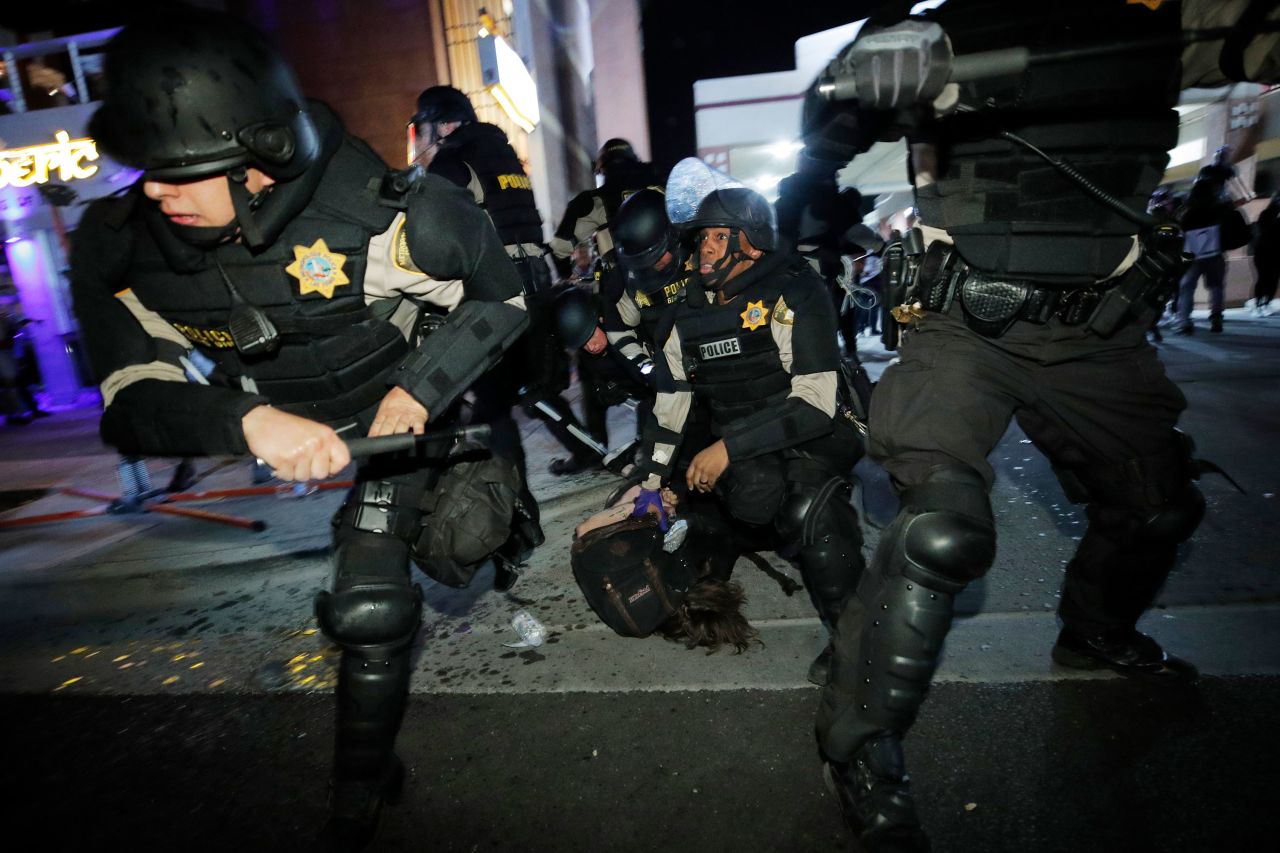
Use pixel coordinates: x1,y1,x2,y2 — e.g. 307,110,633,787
72,12,526,849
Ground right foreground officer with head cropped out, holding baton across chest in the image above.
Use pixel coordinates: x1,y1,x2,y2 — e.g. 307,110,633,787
804,0,1280,850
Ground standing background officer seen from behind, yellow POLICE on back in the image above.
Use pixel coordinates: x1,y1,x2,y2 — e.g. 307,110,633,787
410,86,560,578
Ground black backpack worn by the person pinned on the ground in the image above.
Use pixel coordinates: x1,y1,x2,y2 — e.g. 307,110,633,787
570,517,698,637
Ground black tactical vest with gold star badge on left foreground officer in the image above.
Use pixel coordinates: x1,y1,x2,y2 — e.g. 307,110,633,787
125,138,408,423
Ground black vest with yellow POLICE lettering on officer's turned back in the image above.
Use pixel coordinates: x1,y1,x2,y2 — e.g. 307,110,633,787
429,122,543,246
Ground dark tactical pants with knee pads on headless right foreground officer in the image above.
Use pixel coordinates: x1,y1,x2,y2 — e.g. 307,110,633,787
818,309,1202,761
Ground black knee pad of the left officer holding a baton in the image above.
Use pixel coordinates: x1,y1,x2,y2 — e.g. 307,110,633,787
316,533,422,646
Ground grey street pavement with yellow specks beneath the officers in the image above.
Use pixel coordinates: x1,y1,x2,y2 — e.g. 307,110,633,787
0,311,1280,852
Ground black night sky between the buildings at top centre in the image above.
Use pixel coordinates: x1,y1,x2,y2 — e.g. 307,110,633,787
640,0,876,170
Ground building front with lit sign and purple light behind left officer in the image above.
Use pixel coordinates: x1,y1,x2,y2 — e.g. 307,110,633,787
0,0,649,406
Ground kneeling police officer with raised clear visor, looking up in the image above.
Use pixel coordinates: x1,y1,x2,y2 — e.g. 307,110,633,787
635,159,863,686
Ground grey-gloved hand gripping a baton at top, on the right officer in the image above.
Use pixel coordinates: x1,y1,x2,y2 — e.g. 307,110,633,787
837,20,952,110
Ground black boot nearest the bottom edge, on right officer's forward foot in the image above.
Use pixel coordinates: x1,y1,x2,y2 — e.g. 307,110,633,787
824,734,929,853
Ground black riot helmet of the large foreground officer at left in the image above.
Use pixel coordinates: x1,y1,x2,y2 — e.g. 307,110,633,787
90,10,320,181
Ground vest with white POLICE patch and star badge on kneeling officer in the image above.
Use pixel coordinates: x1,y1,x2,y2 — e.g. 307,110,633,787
676,275,791,427
